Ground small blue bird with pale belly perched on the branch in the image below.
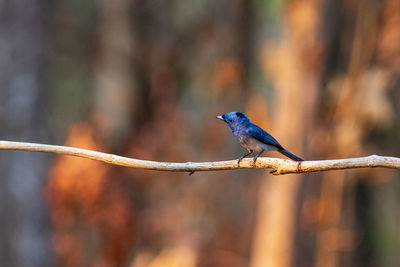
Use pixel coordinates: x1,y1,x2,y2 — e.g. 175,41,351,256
217,111,303,165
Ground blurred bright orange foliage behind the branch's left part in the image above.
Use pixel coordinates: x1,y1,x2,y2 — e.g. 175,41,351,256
46,123,134,266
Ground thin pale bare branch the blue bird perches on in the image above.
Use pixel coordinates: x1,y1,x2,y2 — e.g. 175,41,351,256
0,141,400,175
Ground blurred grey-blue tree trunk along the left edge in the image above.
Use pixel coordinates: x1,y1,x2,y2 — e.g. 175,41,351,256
0,0,52,267
